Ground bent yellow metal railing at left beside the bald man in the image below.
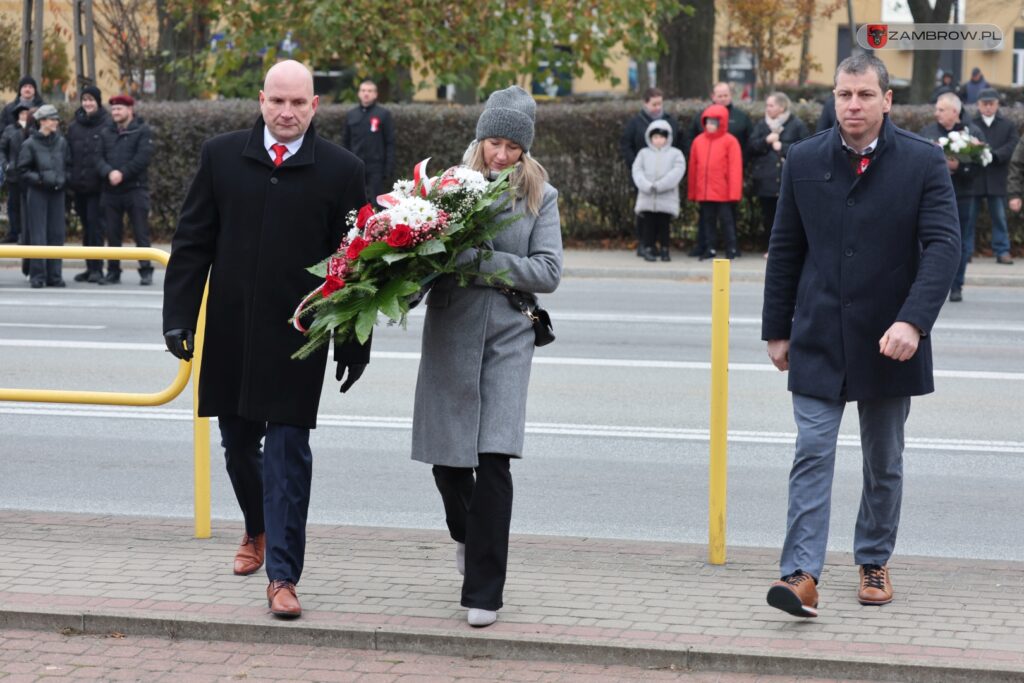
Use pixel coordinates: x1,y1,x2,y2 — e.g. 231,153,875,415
0,245,210,539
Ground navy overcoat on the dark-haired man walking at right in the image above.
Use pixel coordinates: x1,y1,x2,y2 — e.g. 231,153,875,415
761,117,961,400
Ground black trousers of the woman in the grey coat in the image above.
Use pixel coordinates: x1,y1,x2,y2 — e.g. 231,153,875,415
433,453,512,611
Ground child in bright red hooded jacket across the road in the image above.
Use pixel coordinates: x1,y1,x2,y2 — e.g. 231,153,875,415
687,104,743,261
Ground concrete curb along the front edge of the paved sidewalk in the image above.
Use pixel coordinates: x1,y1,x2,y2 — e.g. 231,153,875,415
0,609,1024,683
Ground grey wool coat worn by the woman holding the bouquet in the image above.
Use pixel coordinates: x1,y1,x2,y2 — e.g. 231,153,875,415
413,183,562,467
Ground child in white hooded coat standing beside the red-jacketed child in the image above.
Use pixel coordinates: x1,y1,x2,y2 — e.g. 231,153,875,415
633,119,686,261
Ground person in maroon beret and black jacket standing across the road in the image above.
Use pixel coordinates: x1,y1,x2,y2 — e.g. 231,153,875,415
96,95,153,285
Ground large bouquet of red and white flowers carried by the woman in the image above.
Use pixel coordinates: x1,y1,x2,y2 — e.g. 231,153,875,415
292,159,516,358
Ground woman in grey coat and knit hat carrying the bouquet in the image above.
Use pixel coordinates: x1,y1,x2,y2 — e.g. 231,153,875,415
413,86,562,627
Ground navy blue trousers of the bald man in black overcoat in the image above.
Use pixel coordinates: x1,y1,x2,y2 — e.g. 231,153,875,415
217,415,313,584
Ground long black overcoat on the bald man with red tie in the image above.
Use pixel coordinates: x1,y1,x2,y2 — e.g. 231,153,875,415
164,120,369,427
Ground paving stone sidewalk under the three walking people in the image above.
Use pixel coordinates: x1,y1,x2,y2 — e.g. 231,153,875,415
0,510,1024,683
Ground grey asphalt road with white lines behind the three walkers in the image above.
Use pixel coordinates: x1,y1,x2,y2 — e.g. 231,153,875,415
0,268,1024,560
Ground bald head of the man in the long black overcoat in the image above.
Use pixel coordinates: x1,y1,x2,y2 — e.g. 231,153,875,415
259,59,319,142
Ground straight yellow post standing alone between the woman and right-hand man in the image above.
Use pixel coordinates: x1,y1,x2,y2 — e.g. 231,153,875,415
708,258,730,564
